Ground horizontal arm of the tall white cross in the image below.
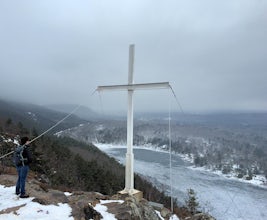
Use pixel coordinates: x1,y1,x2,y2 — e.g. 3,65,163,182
96,82,170,92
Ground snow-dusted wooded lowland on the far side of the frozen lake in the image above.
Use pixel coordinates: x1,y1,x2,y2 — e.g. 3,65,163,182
58,113,267,180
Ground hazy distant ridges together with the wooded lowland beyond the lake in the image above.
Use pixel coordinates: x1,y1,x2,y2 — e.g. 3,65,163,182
0,98,267,182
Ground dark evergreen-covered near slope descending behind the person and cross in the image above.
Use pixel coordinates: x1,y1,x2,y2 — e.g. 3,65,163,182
0,111,180,213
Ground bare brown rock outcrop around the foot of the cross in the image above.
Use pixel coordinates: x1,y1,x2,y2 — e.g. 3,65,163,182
0,174,168,220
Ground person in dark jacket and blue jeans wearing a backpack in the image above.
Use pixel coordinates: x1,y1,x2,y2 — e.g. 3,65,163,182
14,137,32,198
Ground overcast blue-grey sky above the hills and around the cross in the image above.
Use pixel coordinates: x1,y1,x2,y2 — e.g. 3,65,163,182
0,0,267,112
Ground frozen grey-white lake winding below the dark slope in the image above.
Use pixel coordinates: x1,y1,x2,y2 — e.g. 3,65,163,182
96,144,267,220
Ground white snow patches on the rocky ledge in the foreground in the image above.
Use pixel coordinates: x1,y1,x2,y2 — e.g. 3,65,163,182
0,185,179,220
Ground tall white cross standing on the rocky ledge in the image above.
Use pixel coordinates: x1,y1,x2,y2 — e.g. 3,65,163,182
97,44,170,195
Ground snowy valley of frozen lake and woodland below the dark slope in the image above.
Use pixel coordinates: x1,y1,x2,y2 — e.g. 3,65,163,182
56,114,267,220
